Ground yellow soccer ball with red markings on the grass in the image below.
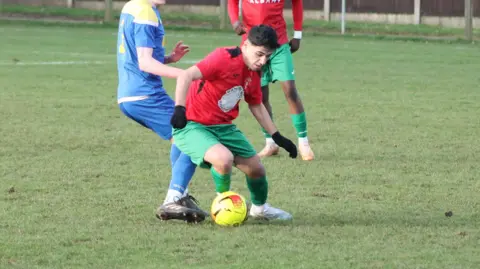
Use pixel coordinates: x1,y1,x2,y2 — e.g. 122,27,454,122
210,191,248,227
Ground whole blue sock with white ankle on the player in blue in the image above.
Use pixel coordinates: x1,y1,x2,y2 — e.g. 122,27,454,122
164,153,197,204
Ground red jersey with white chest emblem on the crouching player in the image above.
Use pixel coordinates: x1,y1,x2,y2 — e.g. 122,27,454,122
186,47,262,125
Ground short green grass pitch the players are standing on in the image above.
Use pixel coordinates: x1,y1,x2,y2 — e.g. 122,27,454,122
0,19,480,269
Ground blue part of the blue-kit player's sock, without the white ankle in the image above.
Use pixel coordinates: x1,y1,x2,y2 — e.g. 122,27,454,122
168,153,197,194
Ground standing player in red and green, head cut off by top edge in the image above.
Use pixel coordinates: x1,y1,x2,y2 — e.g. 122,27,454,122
228,0,315,161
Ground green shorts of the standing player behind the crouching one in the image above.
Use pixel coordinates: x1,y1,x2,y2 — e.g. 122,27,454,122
262,43,295,87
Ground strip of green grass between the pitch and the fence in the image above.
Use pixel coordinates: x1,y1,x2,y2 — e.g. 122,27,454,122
2,5,480,40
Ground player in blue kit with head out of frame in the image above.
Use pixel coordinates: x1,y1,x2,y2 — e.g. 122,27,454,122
117,0,207,221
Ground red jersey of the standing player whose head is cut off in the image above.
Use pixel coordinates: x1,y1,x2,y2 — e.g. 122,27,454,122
228,0,303,45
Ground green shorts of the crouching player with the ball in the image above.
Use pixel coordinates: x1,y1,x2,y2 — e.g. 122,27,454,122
173,121,257,168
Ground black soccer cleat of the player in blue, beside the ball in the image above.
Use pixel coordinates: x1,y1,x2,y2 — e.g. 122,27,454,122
156,195,208,223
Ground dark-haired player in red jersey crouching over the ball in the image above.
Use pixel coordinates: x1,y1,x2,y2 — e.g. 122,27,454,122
172,25,297,220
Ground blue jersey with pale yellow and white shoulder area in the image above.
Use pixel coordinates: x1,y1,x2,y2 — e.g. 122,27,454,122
117,0,165,102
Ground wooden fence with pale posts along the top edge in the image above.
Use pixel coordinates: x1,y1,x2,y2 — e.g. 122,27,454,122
4,0,480,28
